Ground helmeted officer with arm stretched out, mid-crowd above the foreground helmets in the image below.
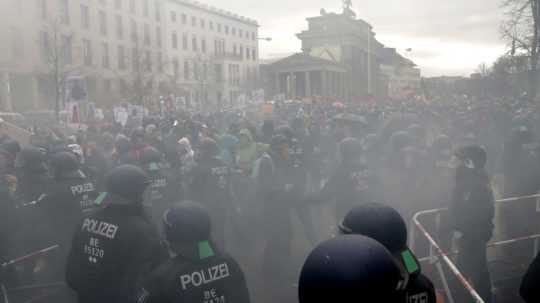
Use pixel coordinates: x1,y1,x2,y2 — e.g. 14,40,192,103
311,138,383,220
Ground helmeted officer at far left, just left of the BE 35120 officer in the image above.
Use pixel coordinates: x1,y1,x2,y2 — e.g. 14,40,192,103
37,151,97,277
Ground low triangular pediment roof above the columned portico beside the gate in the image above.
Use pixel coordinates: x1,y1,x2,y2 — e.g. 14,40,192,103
270,53,345,72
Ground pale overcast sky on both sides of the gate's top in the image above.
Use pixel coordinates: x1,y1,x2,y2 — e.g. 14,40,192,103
204,0,505,76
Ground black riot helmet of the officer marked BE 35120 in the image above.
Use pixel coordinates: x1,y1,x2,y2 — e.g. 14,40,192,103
105,165,149,203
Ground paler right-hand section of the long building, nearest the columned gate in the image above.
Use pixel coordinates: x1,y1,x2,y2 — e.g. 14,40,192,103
165,0,259,109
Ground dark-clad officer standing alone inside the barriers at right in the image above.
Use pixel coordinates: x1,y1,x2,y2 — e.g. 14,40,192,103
449,145,495,302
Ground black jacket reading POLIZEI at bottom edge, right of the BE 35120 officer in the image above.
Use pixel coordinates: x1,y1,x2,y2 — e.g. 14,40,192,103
137,249,249,303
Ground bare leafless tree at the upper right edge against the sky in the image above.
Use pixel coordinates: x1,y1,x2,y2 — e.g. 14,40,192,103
501,0,540,101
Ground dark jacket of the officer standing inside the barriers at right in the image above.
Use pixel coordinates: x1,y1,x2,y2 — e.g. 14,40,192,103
449,169,495,242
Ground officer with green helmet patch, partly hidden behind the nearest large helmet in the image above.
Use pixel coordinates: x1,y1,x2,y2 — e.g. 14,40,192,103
339,203,437,303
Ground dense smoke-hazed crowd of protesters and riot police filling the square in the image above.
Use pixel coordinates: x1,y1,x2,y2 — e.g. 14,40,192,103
0,96,540,303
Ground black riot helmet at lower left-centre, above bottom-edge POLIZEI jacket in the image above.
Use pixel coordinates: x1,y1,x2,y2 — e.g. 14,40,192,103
162,201,211,243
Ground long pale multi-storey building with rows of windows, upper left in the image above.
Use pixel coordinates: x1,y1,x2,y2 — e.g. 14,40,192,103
0,0,258,112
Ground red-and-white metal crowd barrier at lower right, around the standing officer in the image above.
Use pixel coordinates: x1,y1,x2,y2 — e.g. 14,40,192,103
409,194,540,303
